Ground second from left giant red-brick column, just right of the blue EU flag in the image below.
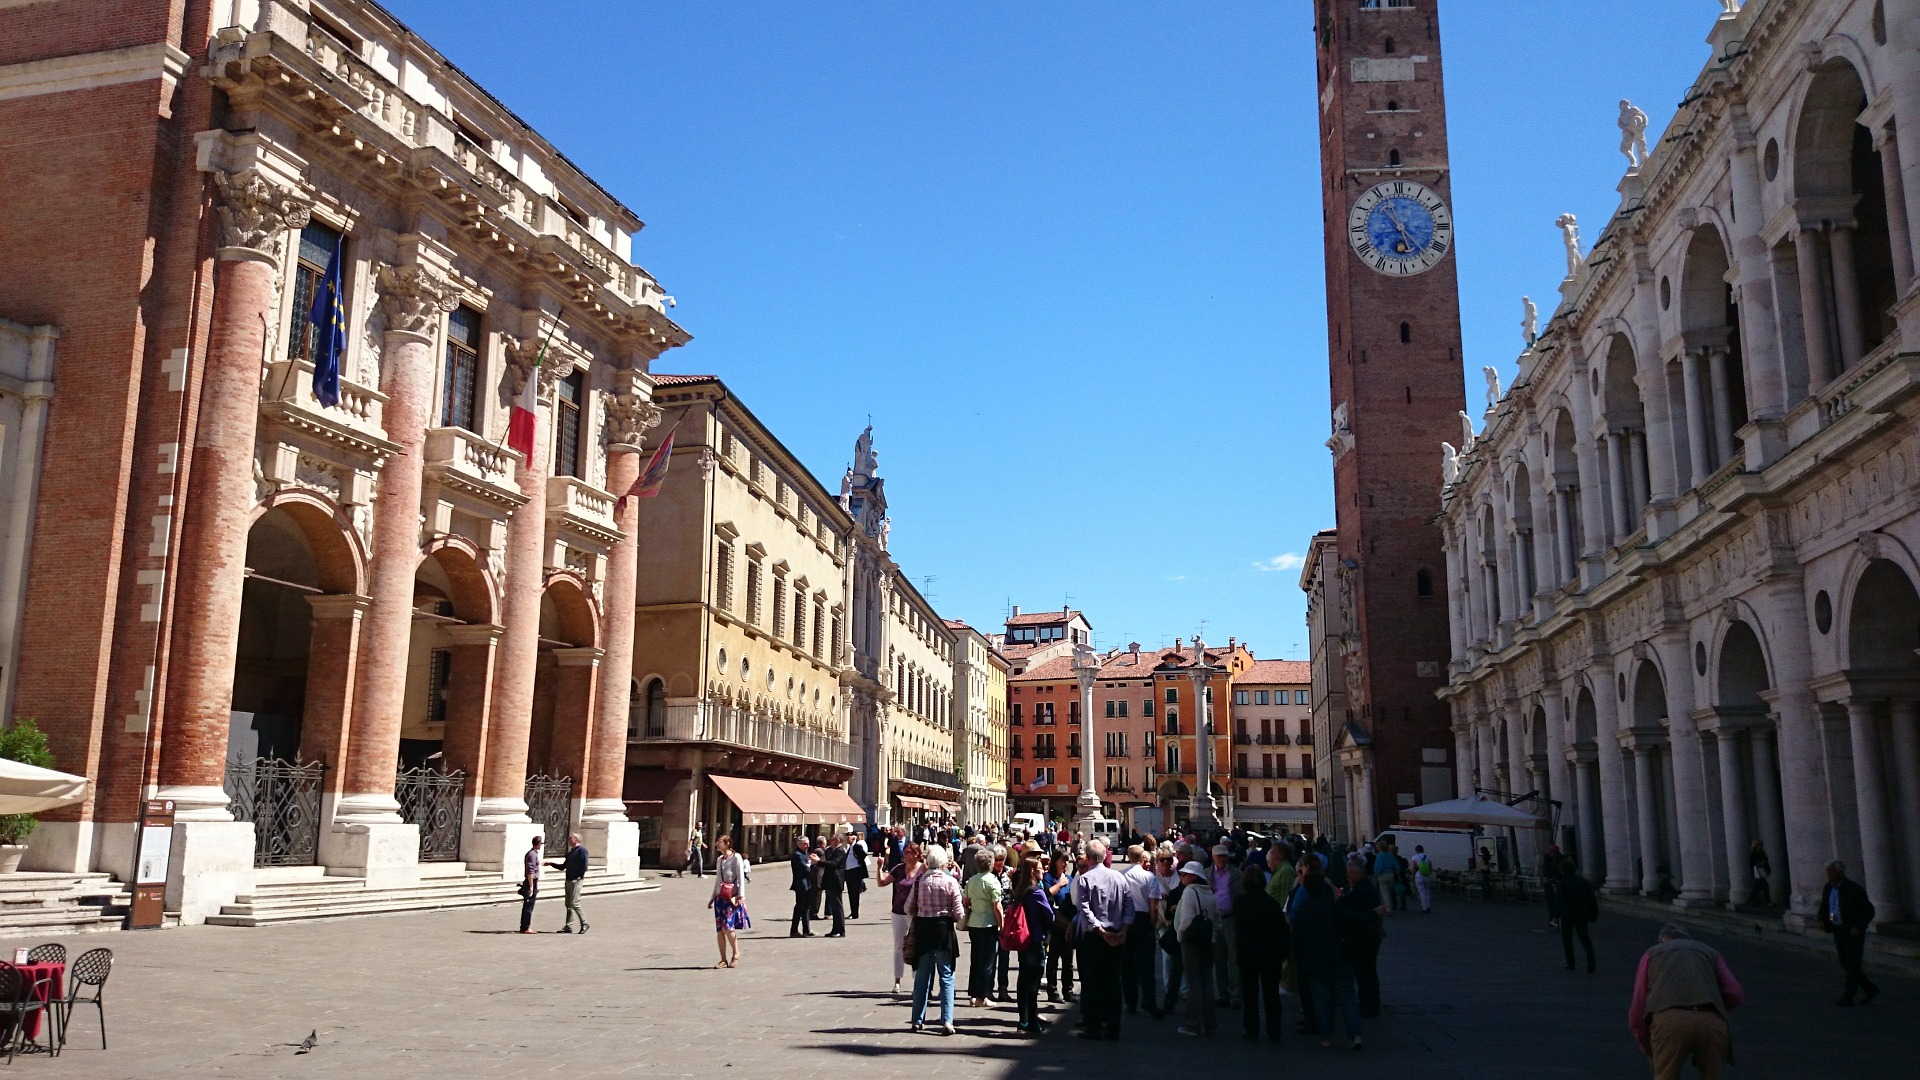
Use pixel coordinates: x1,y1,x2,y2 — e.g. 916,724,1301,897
321,251,459,888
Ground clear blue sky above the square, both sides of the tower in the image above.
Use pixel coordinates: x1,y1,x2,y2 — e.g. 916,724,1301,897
384,0,1718,657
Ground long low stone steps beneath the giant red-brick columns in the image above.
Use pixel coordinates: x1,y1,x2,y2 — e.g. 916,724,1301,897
207,863,660,926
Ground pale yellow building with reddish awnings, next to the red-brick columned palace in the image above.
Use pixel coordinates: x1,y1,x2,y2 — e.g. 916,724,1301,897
626,375,864,867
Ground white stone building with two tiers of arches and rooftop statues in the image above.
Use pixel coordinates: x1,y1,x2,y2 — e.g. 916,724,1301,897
1434,0,1920,941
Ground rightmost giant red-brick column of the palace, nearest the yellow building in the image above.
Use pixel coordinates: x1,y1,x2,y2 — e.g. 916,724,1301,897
580,394,660,876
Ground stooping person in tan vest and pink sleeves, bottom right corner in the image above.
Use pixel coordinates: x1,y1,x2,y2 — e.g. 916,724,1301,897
1626,922,1747,1080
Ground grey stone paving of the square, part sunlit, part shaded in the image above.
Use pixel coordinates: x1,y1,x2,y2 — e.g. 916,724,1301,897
13,867,1920,1080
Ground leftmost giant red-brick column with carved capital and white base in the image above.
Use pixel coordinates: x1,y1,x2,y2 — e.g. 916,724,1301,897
156,171,309,922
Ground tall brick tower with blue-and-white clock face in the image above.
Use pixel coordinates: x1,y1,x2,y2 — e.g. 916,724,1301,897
1313,0,1465,840
